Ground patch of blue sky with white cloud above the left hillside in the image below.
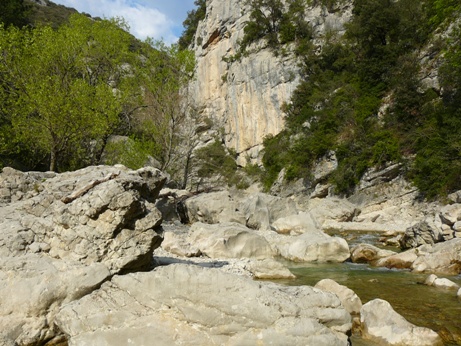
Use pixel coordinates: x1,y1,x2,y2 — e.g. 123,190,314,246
52,0,195,43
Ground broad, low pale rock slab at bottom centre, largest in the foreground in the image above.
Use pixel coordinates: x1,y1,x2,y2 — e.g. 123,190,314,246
56,264,351,346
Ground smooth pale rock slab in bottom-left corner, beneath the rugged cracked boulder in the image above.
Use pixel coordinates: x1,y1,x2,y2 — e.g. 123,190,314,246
0,254,110,345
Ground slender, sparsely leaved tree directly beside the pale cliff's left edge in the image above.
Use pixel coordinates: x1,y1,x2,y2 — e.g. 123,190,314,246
131,41,195,178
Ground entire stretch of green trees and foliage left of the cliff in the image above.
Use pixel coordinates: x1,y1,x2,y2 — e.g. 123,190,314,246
0,14,194,176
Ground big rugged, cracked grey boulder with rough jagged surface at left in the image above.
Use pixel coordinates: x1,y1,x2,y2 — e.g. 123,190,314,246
0,166,166,273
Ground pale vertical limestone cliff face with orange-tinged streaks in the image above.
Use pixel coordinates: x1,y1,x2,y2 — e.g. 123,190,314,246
190,0,350,163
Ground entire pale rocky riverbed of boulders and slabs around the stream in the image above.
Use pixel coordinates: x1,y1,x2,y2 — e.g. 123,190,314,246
0,166,461,345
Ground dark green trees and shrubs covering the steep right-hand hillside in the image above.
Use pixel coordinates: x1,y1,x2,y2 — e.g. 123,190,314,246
248,0,461,198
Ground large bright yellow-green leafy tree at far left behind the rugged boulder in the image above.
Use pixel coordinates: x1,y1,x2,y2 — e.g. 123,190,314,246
0,15,138,171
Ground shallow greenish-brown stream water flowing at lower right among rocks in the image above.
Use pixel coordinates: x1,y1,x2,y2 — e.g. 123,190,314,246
285,263,461,346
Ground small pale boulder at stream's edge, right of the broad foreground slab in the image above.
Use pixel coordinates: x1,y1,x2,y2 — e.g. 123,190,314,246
360,299,442,346
